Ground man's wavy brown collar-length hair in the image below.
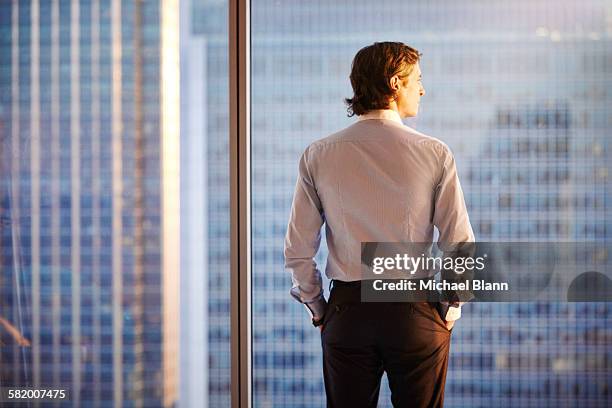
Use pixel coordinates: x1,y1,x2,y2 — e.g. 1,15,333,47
344,42,421,116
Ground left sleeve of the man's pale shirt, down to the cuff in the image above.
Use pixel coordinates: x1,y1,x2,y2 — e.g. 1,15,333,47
284,149,327,320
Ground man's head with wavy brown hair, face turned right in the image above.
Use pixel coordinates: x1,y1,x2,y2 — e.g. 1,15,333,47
345,42,425,118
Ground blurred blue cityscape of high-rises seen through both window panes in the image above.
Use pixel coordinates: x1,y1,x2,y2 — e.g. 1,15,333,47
0,0,612,407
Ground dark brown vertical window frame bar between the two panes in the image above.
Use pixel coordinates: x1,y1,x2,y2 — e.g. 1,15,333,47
228,0,252,408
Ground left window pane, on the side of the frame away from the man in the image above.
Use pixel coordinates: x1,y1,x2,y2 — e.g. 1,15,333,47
0,0,230,406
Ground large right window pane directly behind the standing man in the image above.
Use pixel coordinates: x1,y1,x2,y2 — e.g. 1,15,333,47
251,0,612,407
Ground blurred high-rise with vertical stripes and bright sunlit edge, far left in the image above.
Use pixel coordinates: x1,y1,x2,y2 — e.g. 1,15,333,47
0,0,179,406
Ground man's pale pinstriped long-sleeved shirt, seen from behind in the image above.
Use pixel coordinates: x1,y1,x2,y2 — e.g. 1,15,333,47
284,109,474,319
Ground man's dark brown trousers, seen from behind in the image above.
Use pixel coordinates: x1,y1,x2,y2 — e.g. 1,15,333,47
321,281,451,408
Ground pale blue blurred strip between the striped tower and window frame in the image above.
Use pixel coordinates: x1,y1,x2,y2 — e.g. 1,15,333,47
180,0,231,407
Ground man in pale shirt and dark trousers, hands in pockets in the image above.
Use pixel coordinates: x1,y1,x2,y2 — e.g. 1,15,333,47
285,42,474,408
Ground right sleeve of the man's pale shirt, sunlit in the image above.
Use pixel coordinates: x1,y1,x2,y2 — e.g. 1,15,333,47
433,146,475,310
